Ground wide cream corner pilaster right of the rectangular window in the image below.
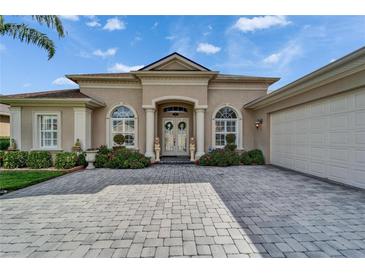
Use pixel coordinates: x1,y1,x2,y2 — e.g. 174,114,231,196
74,108,92,150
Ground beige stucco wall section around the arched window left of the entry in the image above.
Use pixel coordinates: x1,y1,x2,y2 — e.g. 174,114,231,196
80,85,146,152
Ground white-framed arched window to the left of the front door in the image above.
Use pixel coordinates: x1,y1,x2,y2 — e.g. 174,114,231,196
110,106,136,147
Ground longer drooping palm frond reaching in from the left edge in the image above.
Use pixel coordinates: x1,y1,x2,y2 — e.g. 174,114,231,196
0,23,56,60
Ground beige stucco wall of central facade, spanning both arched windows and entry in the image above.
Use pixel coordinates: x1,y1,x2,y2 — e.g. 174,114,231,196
80,80,267,155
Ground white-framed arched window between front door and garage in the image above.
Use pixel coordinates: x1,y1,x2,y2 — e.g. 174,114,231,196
214,106,239,147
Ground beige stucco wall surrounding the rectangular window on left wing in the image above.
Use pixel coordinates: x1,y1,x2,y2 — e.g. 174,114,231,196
21,106,75,151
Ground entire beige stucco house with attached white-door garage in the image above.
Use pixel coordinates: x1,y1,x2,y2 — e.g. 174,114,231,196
0,48,365,186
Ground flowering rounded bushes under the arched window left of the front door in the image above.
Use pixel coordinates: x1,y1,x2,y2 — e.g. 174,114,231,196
95,146,151,169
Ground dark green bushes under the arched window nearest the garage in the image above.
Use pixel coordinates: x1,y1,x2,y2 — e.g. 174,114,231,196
198,148,265,166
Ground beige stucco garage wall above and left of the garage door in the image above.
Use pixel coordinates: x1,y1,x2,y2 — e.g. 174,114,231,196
246,71,365,162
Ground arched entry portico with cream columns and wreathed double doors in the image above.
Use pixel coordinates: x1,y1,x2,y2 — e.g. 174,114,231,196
143,95,207,159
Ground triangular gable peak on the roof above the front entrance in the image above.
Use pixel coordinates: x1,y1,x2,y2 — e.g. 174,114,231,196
139,52,210,71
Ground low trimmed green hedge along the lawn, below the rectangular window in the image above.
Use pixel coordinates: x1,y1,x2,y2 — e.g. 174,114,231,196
0,151,86,169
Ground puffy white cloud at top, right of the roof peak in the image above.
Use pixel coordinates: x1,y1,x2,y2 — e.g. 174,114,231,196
233,15,291,32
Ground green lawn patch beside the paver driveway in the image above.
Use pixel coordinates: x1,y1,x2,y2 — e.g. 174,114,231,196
0,170,64,191
